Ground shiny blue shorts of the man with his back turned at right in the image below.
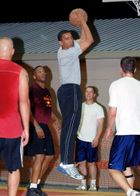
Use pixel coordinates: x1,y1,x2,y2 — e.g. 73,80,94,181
108,135,140,171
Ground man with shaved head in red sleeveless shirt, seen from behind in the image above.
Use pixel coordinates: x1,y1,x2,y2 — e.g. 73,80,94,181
0,37,30,196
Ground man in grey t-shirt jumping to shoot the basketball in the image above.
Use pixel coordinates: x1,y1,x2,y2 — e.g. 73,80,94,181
57,9,93,180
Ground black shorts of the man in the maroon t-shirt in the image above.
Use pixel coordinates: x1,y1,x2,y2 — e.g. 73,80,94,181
24,124,54,156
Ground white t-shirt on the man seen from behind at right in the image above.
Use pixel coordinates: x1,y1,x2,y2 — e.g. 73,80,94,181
109,77,140,135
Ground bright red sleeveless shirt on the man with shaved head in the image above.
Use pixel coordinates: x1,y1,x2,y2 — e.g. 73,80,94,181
0,59,23,138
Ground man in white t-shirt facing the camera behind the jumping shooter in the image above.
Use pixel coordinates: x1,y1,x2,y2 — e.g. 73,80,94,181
76,86,104,191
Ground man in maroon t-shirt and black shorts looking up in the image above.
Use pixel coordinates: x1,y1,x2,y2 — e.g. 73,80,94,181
25,66,54,196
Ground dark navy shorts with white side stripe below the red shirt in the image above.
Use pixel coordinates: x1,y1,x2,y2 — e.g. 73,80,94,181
0,137,23,172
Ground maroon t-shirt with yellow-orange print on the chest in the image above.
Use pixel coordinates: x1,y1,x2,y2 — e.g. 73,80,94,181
30,83,52,124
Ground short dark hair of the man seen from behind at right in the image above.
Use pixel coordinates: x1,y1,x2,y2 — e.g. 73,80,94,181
120,56,136,73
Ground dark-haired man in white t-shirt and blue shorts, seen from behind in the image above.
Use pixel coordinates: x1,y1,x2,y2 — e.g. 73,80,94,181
106,57,140,196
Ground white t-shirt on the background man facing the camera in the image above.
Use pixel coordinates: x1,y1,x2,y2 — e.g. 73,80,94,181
77,102,104,142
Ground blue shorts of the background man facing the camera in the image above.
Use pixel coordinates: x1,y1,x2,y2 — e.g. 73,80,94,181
75,138,98,163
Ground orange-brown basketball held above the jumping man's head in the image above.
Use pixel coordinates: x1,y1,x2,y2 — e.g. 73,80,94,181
69,8,88,26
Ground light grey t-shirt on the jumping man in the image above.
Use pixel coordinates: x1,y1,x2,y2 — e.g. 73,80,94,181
57,41,82,85
